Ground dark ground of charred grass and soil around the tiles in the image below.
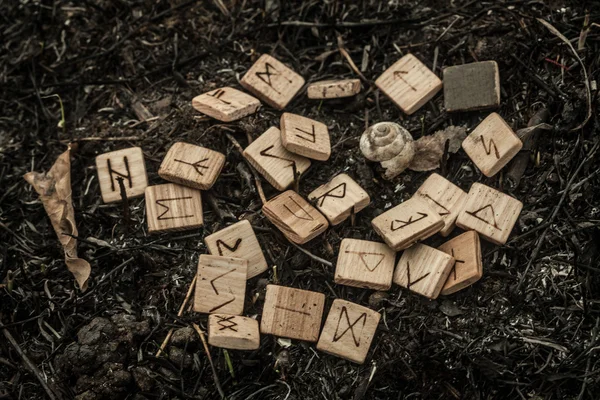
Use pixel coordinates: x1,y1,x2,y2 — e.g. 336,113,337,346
0,0,600,399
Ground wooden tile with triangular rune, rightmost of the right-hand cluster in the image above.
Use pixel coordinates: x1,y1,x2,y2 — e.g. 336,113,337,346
456,183,523,244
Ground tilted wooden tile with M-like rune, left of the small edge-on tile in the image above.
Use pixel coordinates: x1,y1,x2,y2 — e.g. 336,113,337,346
240,54,304,110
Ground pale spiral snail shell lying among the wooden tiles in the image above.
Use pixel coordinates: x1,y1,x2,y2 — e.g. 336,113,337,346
360,122,415,161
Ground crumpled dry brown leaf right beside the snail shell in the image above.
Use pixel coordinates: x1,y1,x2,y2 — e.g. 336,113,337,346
408,126,467,172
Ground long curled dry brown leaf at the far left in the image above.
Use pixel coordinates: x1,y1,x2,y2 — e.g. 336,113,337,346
24,146,92,291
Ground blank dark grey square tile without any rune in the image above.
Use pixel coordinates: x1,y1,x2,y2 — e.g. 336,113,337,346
444,61,500,112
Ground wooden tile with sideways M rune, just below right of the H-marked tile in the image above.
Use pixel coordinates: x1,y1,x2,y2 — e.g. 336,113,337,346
146,183,204,233
